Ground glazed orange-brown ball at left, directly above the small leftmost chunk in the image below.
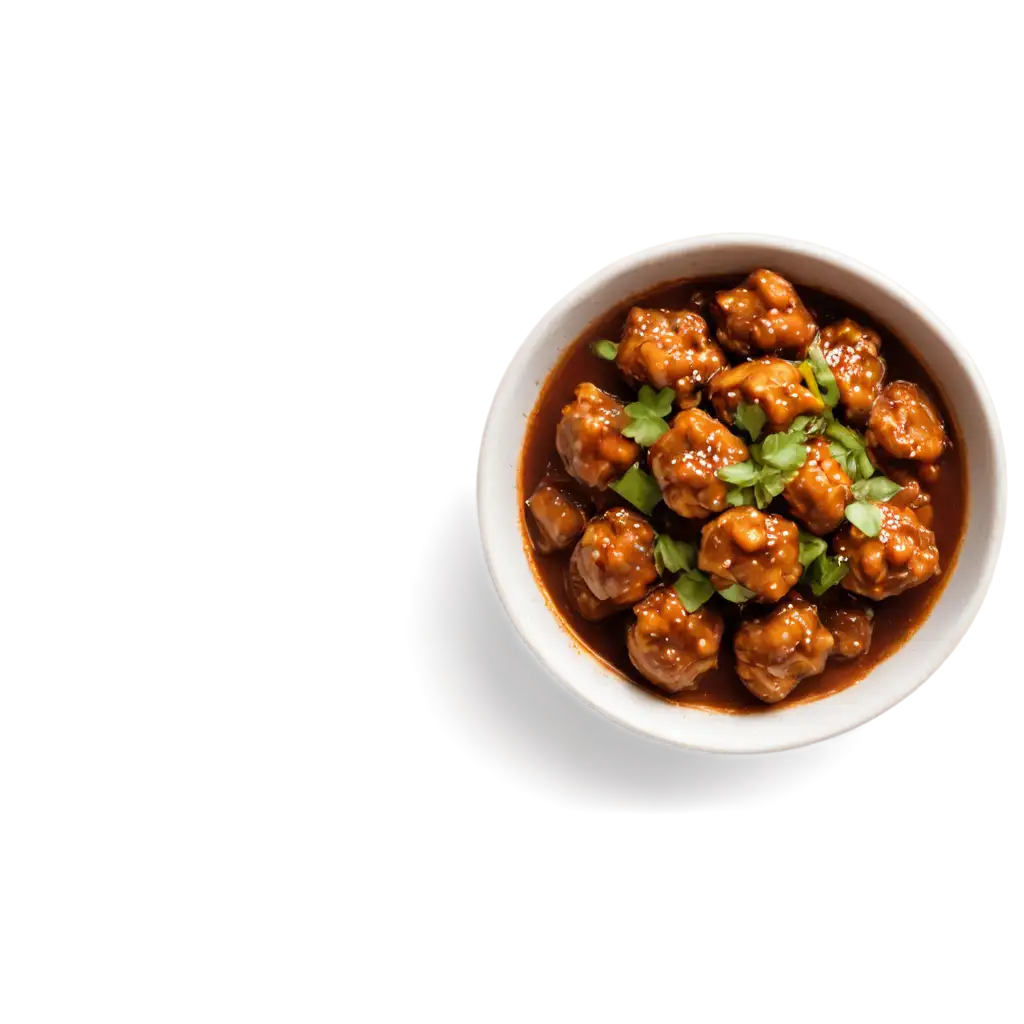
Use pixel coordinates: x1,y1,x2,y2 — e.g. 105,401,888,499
555,383,640,490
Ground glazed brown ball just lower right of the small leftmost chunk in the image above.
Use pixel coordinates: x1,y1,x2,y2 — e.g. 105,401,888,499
569,508,657,620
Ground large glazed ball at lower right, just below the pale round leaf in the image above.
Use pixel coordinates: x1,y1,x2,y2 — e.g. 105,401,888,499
833,502,939,601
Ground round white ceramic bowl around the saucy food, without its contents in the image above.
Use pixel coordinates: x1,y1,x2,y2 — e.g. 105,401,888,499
474,232,1002,755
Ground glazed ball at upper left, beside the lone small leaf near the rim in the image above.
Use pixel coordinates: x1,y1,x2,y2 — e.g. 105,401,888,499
615,306,729,409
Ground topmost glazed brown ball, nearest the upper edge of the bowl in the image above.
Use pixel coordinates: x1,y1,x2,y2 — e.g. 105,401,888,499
715,270,818,359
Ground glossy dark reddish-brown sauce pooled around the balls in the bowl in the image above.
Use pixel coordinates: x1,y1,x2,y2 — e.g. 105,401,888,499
519,274,968,713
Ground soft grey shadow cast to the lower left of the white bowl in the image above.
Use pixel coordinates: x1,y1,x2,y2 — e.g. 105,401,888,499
399,482,859,815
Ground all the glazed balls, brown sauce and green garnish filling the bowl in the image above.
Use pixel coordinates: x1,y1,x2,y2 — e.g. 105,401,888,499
520,269,967,711
